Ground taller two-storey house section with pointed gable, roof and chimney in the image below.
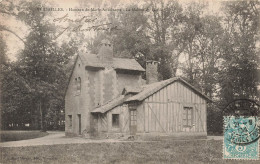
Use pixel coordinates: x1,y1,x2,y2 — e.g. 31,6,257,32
65,40,144,135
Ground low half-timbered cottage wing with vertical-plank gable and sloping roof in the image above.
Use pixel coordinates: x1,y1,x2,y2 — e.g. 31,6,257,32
91,77,210,136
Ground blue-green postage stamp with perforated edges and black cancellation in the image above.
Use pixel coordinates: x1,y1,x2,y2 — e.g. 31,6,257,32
223,116,259,160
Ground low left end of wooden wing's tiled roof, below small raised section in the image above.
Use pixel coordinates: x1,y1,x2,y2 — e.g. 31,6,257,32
91,95,125,113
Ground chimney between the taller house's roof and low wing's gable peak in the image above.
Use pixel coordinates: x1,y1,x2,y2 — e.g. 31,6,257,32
146,60,158,84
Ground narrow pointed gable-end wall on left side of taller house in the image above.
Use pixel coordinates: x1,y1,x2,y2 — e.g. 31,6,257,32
65,58,90,135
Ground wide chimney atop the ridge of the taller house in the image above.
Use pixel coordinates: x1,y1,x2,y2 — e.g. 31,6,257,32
98,39,113,63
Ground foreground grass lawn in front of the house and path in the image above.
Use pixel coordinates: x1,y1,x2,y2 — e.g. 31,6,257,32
0,140,259,164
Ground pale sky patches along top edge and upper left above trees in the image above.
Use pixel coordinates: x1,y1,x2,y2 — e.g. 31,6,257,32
0,0,220,61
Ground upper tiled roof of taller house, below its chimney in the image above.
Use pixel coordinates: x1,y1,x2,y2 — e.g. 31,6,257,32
79,54,145,72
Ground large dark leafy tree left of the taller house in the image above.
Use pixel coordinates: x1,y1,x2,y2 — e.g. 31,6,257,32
1,1,77,131
